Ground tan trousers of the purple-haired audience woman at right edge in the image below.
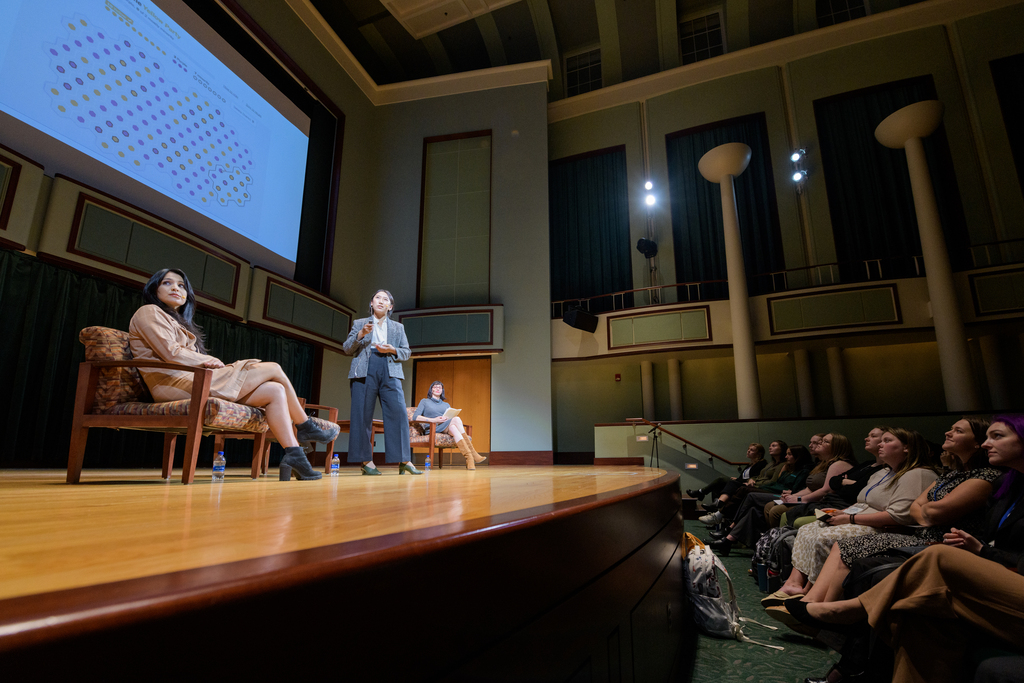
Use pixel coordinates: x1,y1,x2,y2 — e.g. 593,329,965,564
859,546,1024,683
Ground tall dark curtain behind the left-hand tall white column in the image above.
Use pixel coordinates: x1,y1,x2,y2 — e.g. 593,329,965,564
666,114,785,300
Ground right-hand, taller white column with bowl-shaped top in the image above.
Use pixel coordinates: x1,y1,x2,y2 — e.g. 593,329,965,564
874,99,981,413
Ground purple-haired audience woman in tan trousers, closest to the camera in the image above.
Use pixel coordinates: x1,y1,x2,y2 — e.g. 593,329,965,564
786,415,1024,683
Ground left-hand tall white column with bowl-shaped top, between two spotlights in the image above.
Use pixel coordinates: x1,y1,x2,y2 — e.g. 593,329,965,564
697,142,762,419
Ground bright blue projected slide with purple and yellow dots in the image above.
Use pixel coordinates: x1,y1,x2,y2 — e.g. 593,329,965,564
0,0,308,260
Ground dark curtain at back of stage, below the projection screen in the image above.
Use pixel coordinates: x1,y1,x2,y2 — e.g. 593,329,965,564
0,250,313,470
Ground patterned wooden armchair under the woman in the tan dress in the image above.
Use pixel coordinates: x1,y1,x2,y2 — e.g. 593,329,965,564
68,327,269,483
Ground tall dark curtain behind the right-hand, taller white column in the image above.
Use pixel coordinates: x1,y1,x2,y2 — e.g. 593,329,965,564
808,76,970,282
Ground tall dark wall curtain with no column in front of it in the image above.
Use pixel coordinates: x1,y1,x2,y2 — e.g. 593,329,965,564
548,147,633,312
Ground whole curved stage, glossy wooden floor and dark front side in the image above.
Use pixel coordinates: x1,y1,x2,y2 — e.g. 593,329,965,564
0,466,690,681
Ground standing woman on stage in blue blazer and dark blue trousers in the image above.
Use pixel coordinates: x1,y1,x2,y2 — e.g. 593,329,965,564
343,290,423,475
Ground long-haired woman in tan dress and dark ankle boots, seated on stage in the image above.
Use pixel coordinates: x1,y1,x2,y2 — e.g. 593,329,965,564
128,268,339,481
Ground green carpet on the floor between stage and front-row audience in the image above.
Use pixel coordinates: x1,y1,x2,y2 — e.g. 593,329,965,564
688,540,839,683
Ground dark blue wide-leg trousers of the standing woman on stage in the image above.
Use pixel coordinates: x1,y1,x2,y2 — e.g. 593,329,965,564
348,350,412,463
